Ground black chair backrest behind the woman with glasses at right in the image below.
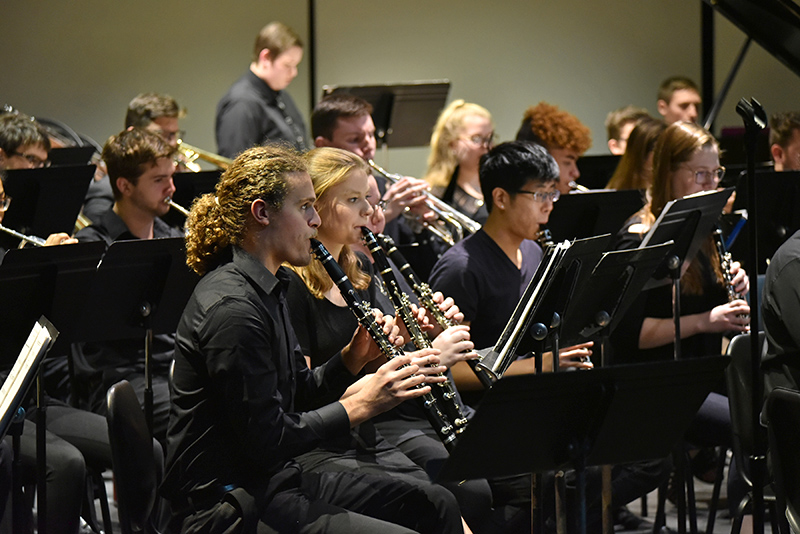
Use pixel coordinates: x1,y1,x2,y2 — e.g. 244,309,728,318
725,332,766,484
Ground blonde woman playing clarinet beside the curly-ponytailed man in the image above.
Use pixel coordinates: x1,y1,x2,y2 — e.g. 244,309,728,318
287,148,529,533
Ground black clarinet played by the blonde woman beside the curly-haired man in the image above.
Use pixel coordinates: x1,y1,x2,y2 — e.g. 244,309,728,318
361,226,467,434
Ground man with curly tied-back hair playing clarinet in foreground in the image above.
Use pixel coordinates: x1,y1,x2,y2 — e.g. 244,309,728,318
162,147,461,533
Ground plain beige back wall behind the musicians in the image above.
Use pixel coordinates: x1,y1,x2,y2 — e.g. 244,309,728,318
0,0,800,175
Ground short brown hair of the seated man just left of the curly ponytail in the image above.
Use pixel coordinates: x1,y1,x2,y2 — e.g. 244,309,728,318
103,128,175,199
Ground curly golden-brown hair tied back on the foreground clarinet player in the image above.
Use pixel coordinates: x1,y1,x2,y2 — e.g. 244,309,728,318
186,145,306,275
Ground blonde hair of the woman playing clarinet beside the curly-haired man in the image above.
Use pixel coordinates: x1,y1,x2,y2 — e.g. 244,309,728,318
291,147,370,299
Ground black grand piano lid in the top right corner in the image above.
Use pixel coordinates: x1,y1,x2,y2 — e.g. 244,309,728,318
705,0,800,76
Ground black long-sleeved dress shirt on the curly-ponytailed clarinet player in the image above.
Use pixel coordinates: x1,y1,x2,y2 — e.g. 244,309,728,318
163,247,354,504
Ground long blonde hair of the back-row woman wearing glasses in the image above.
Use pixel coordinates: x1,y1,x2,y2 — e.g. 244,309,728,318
425,100,492,191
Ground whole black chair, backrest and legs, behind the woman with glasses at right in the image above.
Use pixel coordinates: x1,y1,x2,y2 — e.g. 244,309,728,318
725,332,779,534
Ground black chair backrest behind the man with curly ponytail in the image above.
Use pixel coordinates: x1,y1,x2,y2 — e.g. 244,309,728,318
106,380,158,534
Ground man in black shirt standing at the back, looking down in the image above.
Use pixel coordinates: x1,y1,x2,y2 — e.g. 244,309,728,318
215,22,310,158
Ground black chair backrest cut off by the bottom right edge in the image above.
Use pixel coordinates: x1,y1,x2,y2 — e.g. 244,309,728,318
766,388,800,532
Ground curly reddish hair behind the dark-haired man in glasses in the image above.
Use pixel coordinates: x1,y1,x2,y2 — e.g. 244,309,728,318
517,102,592,155
